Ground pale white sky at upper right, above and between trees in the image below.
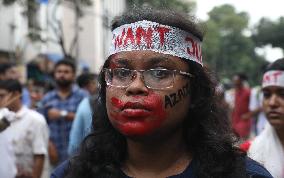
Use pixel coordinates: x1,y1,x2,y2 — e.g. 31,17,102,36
196,0,284,62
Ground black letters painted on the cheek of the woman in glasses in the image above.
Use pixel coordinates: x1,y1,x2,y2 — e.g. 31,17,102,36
165,84,189,108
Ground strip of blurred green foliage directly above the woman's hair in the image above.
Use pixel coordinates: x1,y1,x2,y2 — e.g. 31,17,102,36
126,0,196,13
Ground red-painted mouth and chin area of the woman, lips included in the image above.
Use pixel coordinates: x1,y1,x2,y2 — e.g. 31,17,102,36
110,93,166,136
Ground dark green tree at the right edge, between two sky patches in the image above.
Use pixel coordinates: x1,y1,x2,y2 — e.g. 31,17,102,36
253,17,284,49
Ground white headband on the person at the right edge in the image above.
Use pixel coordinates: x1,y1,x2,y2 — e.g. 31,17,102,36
262,70,284,88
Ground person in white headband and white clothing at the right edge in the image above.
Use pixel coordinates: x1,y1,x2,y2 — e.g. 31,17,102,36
248,58,284,178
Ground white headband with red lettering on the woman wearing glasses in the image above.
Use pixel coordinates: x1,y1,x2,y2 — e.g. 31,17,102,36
109,20,203,65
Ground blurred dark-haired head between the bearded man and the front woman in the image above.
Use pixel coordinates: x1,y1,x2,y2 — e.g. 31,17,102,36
77,73,98,95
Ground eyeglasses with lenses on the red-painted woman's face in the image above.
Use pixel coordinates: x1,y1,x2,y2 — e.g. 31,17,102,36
104,68,194,89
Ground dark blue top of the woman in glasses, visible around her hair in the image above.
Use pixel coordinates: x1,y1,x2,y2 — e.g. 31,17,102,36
51,158,273,178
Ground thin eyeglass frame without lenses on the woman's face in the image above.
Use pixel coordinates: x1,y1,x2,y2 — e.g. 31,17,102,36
103,67,194,90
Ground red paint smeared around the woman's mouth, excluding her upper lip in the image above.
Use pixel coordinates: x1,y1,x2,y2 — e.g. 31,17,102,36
110,93,166,136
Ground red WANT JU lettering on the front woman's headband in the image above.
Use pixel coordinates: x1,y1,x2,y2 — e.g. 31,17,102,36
113,26,202,63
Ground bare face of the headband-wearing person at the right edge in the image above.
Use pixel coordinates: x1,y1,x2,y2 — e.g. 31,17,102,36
262,86,284,131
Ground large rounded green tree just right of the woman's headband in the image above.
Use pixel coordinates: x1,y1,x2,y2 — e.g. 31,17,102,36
203,5,267,84
